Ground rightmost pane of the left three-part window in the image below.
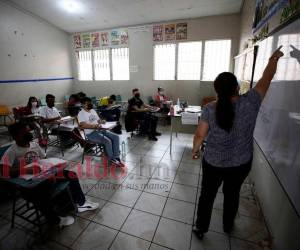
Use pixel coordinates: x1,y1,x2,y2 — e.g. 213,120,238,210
111,48,129,80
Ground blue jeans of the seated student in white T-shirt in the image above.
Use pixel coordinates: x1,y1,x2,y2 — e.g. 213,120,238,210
86,131,120,160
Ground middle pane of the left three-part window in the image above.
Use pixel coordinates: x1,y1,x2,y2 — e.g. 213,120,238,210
94,49,110,81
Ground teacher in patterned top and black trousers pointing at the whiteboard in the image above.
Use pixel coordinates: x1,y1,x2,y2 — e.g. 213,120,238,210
193,46,283,238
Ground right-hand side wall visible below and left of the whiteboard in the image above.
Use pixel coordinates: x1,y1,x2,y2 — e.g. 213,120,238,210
240,0,300,250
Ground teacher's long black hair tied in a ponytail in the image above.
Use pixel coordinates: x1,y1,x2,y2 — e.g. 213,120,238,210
214,72,238,132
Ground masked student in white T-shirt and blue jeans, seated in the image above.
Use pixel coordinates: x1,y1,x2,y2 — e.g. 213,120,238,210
78,97,124,167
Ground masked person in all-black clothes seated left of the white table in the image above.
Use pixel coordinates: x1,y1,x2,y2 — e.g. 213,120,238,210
128,89,161,141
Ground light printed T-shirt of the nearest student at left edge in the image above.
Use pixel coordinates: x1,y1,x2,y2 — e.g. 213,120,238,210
0,142,46,166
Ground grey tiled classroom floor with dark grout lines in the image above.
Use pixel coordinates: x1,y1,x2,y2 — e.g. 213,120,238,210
0,127,270,250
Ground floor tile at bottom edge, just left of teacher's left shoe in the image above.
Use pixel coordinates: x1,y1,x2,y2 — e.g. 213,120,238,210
153,218,192,250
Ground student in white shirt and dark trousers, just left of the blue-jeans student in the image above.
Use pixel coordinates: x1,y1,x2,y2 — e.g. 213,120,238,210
40,94,85,146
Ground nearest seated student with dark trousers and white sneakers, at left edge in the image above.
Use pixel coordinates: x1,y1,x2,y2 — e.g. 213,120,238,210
0,123,99,226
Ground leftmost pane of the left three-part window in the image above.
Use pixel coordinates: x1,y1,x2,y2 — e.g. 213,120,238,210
77,50,93,81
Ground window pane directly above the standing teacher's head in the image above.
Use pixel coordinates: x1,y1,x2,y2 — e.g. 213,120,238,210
203,40,231,81
